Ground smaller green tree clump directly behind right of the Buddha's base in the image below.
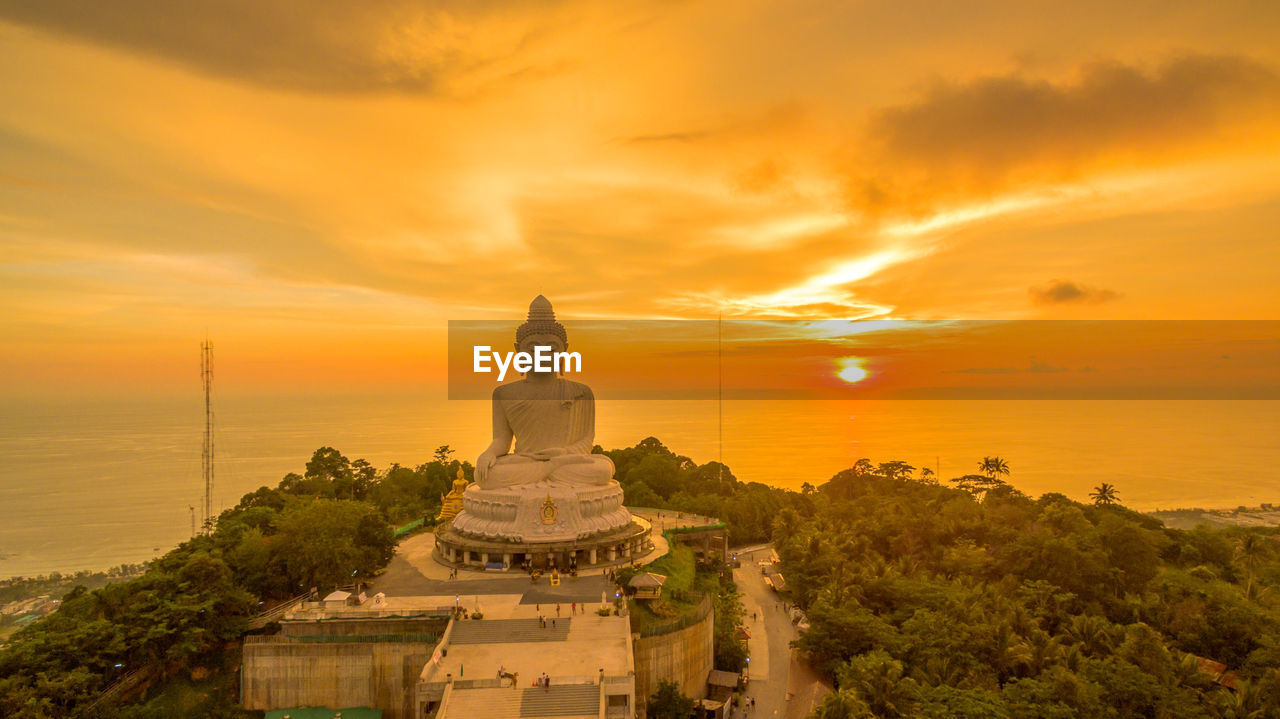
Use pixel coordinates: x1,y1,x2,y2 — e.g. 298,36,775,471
595,438,813,545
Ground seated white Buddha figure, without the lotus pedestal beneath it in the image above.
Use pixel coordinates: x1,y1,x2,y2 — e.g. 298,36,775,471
476,294,613,489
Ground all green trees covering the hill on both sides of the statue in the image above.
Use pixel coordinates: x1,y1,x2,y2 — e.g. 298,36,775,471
0,438,1280,719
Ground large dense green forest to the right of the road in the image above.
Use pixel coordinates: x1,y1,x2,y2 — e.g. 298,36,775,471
774,458,1280,719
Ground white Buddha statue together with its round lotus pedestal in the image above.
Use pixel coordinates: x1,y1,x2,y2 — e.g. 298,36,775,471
453,296,631,542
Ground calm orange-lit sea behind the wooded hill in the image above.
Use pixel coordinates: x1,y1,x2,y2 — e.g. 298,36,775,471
0,393,1280,577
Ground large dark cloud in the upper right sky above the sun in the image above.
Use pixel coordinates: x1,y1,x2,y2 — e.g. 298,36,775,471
849,55,1280,214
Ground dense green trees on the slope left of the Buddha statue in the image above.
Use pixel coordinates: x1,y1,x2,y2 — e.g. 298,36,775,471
0,448,445,718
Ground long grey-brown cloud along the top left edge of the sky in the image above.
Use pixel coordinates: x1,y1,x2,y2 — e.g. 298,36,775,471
0,0,593,92
